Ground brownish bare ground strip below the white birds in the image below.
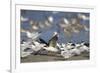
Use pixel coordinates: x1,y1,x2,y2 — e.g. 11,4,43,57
21,53,89,63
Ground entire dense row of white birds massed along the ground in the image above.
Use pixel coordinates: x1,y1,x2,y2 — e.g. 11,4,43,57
21,38,89,59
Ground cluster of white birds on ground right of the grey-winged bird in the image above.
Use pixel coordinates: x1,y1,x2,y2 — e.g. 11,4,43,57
61,43,89,58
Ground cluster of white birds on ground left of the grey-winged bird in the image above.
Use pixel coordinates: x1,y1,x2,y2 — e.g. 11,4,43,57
21,41,45,57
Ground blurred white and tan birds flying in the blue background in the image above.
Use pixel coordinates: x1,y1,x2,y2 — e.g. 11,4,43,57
21,13,89,35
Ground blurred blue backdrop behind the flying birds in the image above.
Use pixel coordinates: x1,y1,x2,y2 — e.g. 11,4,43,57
21,10,90,43
